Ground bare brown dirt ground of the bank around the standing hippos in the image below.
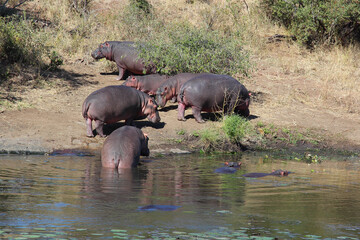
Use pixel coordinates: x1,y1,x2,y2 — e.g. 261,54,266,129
0,47,360,155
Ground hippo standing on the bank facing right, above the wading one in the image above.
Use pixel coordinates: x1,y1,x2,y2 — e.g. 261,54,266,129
82,85,160,137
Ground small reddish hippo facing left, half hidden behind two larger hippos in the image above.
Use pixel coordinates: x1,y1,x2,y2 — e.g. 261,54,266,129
123,74,169,95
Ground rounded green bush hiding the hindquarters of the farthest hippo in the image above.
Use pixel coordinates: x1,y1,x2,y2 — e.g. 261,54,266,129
138,24,250,75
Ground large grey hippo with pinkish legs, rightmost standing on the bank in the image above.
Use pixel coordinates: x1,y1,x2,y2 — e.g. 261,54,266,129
177,73,250,123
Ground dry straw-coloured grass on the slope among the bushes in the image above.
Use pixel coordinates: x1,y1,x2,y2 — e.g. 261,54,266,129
21,0,360,113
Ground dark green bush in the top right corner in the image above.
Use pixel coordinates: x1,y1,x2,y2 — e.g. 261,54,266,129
262,0,360,47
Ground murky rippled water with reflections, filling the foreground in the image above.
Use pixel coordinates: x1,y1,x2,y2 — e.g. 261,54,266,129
0,154,360,239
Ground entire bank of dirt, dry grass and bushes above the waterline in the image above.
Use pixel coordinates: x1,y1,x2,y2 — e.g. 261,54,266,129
0,0,360,161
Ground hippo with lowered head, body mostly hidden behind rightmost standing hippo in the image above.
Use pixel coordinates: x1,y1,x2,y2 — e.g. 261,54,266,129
155,73,202,107
